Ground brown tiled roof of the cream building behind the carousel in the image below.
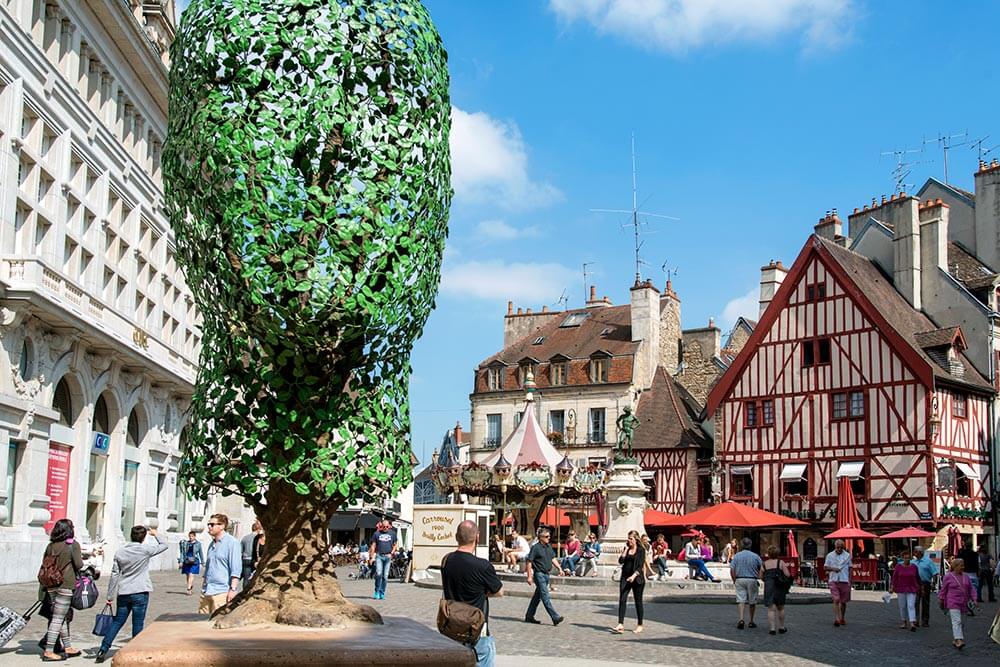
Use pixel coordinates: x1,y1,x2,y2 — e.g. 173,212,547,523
479,305,639,367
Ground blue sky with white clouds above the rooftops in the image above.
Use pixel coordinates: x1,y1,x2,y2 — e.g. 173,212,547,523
174,0,1000,462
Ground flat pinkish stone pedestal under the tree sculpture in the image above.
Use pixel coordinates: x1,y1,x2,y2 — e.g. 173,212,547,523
113,614,476,667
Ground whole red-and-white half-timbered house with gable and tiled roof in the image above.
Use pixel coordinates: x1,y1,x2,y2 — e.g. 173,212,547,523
706,235,994,542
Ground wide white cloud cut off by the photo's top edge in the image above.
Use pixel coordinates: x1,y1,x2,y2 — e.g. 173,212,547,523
549,0,858,53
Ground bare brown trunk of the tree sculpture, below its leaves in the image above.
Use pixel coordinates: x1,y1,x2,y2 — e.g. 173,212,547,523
213,481,382,628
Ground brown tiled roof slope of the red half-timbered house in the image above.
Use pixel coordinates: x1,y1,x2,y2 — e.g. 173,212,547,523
815,237,993,391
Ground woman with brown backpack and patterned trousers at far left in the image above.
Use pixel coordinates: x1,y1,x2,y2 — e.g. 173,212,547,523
38,519,83,662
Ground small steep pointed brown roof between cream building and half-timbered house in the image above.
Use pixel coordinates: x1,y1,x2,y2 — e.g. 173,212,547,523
632,366,709,449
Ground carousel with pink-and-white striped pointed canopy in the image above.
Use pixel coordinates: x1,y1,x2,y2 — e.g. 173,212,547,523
431,373,609,539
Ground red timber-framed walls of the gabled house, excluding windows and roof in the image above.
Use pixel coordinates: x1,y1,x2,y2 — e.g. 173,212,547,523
706,236,988,525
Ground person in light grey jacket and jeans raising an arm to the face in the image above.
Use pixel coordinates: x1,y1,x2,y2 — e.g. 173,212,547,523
95,526,168,662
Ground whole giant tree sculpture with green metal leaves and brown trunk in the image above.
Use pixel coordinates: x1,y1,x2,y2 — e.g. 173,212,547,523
163,0,452,627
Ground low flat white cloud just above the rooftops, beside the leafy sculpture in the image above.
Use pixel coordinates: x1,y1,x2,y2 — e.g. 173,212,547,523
441,260,578,305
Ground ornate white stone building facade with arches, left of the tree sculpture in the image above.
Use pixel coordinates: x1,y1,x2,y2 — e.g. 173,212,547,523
0,0,249,583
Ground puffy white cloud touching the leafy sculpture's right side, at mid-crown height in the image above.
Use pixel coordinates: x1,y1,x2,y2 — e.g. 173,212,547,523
451,107,562,209
